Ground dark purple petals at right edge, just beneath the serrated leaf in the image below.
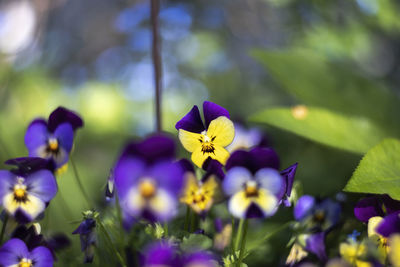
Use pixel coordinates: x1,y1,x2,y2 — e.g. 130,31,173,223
354,194,400,223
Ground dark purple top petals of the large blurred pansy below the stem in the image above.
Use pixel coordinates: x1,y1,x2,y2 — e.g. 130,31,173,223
122,134,175,164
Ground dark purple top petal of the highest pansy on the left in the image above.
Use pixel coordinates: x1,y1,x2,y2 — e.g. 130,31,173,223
48,107,83,132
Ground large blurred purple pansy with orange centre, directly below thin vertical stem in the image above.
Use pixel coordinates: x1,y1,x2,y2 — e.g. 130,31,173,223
114,135,183,227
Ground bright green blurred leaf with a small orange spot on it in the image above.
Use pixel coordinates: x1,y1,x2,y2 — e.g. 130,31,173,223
250,106,390,154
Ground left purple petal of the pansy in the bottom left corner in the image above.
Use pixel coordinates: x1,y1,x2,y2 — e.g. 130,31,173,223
0,238,29,266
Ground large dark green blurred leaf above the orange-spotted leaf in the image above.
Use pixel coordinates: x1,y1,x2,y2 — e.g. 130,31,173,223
252,49,400,133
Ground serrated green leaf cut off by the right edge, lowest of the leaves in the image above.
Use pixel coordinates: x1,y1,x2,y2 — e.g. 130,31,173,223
344,139,400,200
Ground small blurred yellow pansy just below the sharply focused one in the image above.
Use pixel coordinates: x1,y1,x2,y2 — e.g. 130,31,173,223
180,160,218,214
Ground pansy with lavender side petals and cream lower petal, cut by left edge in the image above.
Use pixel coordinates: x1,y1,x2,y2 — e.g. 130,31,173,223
0,162,57,223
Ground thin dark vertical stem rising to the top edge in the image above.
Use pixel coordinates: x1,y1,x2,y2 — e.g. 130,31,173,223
150,0,162,132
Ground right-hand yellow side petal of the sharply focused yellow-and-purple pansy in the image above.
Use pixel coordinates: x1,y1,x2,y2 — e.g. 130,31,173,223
207,116,235,147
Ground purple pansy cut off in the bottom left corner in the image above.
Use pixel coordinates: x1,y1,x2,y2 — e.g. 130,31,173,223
0,238,54,267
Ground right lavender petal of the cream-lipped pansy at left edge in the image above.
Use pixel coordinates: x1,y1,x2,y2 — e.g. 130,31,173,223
25,170,58,202
